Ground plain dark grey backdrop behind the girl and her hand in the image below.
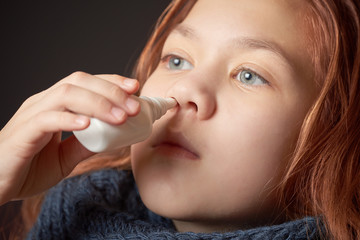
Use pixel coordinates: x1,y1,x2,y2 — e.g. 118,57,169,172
0,0,170,239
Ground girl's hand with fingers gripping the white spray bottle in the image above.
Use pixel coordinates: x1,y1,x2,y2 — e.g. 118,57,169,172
0,72,140,205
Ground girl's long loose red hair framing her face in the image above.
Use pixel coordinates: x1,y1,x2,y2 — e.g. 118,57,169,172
8,0,360,239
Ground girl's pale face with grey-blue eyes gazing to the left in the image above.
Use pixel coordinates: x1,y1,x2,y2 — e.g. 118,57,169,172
131,0,318,232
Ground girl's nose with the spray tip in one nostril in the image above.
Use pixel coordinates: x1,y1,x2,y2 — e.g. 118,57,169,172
167,72,216,120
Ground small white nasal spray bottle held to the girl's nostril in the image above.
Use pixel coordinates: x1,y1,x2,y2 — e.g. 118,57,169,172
74,96,177,152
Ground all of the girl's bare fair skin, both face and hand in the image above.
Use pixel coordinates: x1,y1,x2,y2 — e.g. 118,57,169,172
0,0,318,232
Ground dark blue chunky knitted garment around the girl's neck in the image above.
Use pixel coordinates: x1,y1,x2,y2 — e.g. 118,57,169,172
27,170,319,240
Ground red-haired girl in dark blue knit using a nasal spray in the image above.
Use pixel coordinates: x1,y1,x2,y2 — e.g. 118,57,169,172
0,0,360,239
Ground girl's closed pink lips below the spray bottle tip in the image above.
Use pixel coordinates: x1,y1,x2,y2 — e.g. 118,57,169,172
153,133,199,160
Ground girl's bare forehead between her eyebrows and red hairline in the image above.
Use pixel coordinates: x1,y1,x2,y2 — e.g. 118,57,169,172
167,0,311,80
